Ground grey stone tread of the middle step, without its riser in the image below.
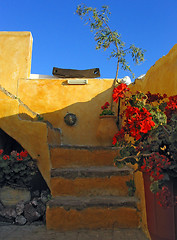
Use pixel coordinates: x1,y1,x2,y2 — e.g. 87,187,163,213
51,166,133,178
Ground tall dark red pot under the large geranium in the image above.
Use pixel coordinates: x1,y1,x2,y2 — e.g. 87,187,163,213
143,174,177,240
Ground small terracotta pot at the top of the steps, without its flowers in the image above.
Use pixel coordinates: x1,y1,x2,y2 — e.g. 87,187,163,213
96,115,118,146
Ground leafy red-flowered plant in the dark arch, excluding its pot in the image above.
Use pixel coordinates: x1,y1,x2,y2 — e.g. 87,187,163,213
0,149,37,188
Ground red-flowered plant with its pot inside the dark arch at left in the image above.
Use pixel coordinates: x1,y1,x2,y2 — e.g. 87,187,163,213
0,149,37,205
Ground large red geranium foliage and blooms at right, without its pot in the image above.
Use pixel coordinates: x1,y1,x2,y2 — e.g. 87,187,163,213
113,88,177,207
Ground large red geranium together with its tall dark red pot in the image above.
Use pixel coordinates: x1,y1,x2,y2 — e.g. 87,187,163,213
113,89,177,240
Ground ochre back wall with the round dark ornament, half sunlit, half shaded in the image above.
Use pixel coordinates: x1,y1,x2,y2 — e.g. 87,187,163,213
18,79,116,146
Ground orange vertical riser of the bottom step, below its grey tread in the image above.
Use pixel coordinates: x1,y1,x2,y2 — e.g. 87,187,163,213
46,207,139,231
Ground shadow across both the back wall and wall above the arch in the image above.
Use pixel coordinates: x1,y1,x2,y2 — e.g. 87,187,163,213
0,88,116,186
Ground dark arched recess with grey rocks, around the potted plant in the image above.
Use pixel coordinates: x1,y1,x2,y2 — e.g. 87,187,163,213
0,129,50,225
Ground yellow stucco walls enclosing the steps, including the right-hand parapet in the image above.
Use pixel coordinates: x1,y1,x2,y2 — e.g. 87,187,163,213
0,32,177,236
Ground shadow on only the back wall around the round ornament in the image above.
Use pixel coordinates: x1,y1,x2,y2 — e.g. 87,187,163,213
20,88,117,146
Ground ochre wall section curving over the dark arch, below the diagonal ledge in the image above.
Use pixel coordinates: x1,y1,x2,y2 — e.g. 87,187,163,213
0,99,51,187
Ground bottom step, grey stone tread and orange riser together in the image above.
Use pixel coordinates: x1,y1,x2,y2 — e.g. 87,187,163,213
46,196,140,231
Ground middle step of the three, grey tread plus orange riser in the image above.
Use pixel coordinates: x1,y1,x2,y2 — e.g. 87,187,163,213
51,166,132,196
